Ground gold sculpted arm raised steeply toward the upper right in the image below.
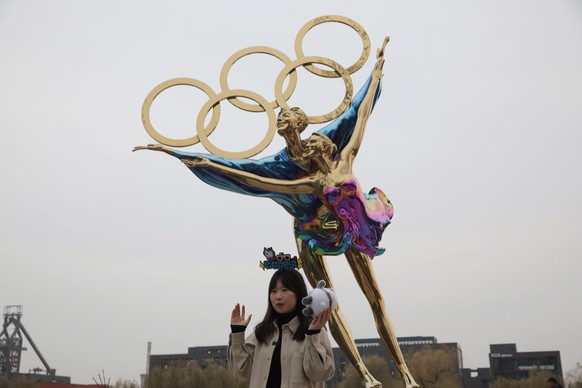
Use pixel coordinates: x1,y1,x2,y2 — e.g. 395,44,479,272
340,37,390,169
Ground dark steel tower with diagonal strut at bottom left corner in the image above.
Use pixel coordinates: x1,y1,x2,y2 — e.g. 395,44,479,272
0,306,56,376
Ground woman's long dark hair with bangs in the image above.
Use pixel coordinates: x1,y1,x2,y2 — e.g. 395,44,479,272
255,269,309,344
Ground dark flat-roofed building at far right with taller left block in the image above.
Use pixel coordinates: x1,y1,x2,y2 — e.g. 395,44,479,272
489,344,562,381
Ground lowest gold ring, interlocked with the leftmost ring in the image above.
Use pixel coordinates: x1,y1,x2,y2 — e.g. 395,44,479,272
196,89,276,159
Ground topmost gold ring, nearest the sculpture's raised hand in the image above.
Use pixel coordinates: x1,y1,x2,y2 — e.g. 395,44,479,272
295,15,370,78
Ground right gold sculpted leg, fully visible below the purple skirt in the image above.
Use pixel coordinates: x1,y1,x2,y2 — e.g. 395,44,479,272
345,248,419,388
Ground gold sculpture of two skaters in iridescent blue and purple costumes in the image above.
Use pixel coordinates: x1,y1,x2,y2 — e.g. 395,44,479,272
134,15,418,388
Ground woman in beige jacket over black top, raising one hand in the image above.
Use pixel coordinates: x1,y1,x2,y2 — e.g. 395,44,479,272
228,270,335,388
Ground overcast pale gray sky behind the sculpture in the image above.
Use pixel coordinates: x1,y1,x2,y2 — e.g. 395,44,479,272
0,0,582,383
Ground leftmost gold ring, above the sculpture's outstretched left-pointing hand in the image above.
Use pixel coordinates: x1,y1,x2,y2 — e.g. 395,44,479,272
141,78,220,147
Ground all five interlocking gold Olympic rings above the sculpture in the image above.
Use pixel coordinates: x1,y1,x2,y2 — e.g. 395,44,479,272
141,15,370,158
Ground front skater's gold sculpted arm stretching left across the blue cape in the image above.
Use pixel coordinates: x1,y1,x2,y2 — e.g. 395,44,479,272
182,156,315,194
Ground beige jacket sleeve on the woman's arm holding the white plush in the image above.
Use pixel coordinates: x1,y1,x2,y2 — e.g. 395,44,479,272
303,329,335,381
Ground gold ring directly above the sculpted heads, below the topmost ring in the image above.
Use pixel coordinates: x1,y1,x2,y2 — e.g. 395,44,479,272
275,57,354,124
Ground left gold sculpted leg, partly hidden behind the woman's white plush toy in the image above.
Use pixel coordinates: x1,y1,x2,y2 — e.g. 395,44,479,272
296,233,382,388
